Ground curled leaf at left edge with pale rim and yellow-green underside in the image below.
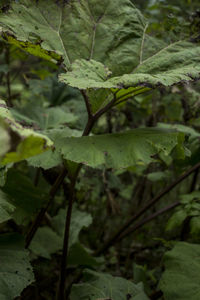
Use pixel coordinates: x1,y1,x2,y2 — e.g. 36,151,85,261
0,100,53,165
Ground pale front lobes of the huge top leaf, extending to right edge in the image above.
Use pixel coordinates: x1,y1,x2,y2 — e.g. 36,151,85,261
59,41,200,90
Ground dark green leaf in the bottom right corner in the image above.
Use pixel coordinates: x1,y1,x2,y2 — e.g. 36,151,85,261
160,242,200,300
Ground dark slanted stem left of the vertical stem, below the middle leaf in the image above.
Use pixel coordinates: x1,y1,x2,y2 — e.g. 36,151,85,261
25,167,67,248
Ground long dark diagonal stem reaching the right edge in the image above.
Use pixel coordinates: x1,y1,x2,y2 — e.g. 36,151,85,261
95,163,200,255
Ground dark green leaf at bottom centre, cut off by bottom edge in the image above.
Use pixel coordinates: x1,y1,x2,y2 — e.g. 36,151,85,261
71,270,149,300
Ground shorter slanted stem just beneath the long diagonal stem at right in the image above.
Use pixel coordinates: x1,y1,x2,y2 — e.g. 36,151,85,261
117,201,180,241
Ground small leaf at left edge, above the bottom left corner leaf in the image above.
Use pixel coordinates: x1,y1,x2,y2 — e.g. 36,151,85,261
0,191,15,223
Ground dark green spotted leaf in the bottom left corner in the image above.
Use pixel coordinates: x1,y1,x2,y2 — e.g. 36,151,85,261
0,234,34,300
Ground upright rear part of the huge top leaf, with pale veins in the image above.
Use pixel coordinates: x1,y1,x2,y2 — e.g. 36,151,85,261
0,0,145,74
